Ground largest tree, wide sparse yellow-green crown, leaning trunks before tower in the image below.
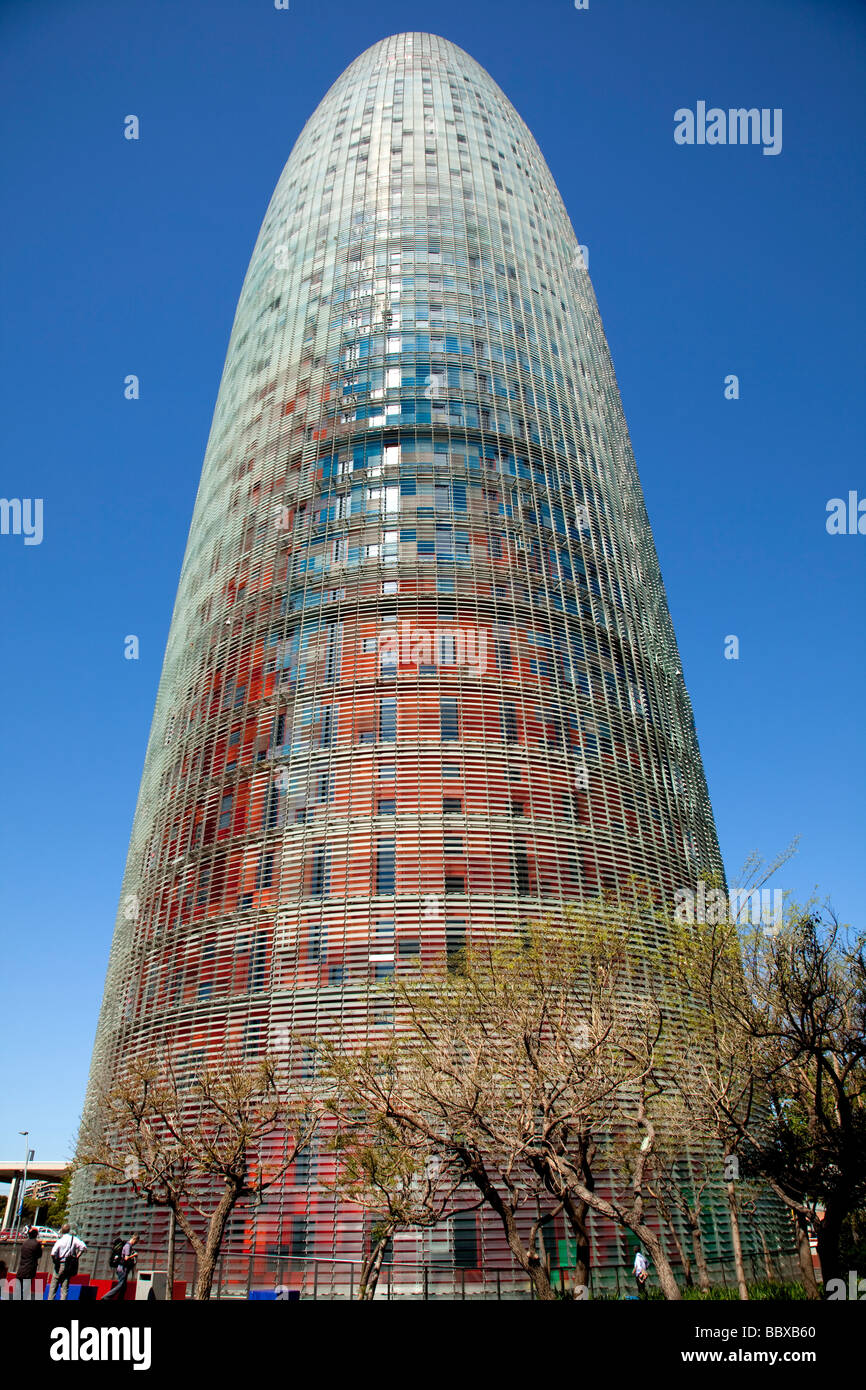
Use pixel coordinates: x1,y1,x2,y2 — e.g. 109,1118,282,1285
322,904,695,1298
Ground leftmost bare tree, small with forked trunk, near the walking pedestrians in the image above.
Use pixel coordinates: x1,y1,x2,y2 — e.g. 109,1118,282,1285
75,1056,318,1298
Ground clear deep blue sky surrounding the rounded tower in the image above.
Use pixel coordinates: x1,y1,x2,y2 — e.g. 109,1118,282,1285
0,0,866,1158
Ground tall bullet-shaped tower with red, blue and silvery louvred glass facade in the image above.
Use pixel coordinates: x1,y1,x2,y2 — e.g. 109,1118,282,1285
81,33,720,1289
